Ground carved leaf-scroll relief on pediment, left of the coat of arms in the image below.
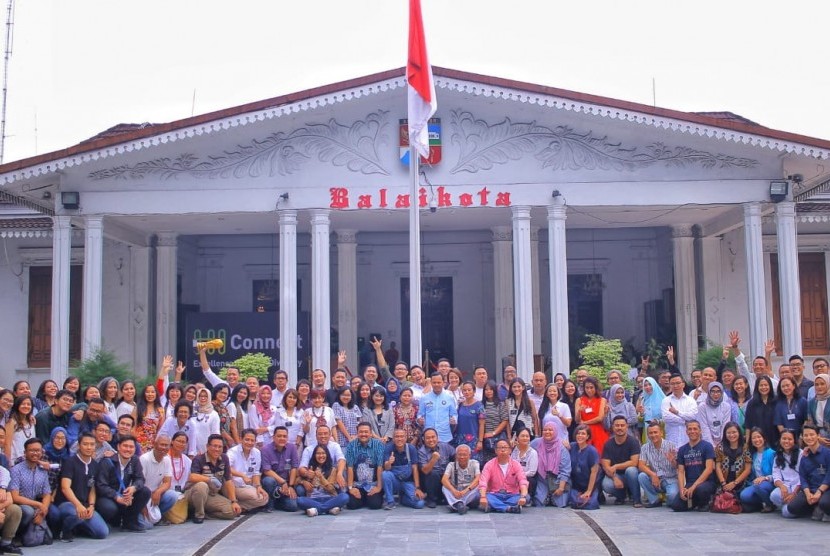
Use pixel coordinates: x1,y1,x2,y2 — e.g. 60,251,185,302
89,110,395,180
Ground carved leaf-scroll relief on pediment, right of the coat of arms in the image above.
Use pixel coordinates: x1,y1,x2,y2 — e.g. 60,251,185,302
450,110,758,174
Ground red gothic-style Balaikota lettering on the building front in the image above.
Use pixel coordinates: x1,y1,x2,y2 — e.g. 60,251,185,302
329,186,510,209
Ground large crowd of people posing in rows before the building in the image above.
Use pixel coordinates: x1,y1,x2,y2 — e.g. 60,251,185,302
0,332,830,554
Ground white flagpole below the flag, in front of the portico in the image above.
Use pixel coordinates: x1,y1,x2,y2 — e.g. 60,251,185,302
409,146,422,368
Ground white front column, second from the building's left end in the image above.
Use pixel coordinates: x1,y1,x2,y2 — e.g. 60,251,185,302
81,216,104,359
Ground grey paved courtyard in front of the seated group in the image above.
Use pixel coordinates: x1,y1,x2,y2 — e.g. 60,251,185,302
19,506,830,556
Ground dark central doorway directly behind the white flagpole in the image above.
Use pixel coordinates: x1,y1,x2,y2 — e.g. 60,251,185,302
401,276,453,364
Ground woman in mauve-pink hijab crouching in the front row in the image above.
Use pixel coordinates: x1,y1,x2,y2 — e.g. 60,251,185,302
533,421,571,508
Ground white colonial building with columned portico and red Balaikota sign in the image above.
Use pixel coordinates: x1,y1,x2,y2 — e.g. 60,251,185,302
0,68,830,385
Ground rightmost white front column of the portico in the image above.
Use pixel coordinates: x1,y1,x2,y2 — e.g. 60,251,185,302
775,201,802,358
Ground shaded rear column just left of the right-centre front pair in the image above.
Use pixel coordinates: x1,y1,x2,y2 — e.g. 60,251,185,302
492,226,515,378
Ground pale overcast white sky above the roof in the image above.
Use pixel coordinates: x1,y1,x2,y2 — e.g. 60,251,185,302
2,0,830,162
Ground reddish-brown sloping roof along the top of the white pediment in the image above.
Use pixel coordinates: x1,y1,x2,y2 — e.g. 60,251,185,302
0,67,830,174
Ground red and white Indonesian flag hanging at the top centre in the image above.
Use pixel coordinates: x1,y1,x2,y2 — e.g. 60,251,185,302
406,0,438,158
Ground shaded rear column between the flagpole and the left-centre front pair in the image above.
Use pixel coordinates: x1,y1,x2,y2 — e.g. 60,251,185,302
337,230,357,362
